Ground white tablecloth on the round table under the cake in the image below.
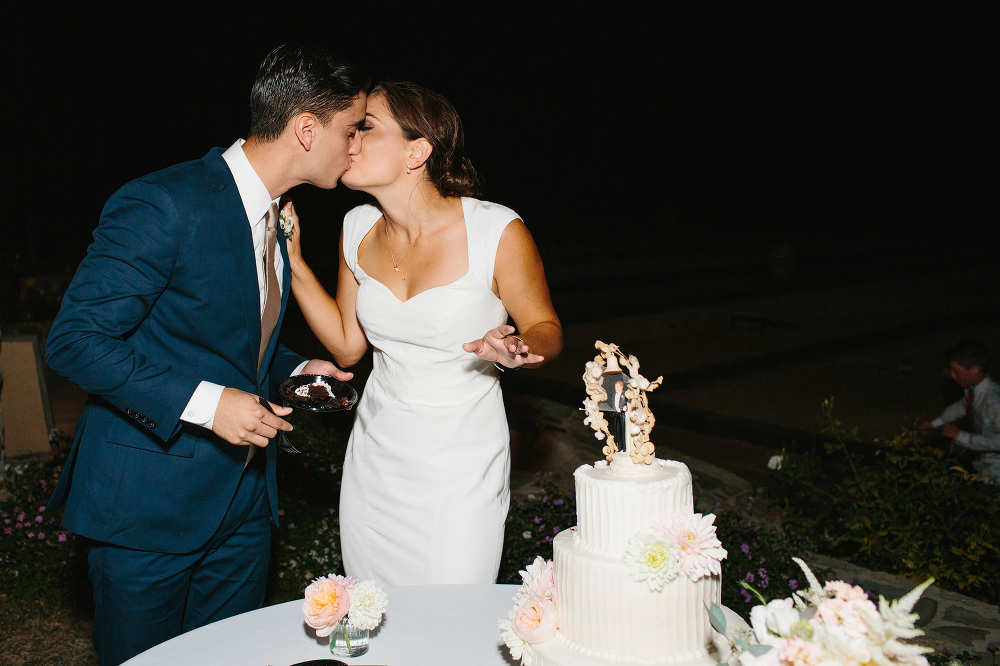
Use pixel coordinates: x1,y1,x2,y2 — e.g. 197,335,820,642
125,585,518,666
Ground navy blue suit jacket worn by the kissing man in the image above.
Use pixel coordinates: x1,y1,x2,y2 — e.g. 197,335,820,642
46,149,305,659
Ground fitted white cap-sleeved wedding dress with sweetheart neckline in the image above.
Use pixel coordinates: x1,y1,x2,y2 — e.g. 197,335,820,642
340,199,518,586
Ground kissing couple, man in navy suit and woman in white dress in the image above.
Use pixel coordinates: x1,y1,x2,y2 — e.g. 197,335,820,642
46,45,562,666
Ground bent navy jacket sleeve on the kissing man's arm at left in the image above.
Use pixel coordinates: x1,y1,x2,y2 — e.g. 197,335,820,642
46,181,198,441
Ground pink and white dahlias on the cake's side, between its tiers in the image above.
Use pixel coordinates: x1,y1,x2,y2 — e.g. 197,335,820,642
624,513,728,591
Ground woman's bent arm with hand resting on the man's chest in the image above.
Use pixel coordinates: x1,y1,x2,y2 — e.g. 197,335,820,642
286,204,368,368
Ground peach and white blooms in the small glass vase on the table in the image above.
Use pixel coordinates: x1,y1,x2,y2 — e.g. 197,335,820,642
302,574,388,636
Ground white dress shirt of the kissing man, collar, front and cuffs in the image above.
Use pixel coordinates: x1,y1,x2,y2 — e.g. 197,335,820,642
181,139,308,430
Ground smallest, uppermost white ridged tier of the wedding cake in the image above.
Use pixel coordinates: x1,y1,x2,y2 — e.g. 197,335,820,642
573,458,694,559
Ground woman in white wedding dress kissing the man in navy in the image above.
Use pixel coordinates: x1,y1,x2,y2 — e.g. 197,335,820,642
285,83,562,585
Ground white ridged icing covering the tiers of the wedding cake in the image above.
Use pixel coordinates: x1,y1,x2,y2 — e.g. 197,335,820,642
532,459,721,666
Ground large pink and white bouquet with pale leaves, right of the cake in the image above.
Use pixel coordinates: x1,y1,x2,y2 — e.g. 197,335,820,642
709,558,934,666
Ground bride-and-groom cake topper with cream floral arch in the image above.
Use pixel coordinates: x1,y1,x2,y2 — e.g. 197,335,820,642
583,340,663,465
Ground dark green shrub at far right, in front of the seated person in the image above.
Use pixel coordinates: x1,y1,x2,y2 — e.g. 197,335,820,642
769,400,1000,604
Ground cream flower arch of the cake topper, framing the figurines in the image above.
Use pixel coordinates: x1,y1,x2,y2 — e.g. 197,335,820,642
583,340,663,465
